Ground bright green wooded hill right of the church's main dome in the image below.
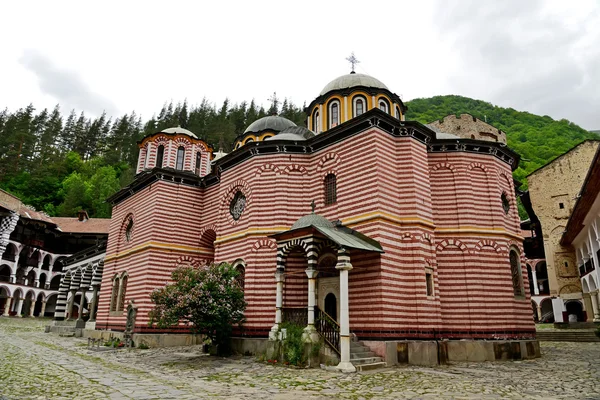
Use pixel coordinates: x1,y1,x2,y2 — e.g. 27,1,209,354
406,95,600,187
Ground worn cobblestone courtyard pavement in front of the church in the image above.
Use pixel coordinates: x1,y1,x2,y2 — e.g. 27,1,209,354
0,317,600,400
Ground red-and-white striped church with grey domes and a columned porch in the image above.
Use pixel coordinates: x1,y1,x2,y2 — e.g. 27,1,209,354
84,68,535,363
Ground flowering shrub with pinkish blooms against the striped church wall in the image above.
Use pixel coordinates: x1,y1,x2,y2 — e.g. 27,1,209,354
150,263,246,352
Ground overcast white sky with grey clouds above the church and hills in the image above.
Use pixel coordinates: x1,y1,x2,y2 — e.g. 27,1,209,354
0,0,600,129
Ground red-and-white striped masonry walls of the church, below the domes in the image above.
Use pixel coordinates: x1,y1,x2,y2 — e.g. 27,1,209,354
96,109,535,339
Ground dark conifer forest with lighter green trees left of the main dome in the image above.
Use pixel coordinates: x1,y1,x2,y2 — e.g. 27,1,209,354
0,96,306,217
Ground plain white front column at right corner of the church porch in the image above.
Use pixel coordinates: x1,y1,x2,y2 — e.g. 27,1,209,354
335,248,356,372
